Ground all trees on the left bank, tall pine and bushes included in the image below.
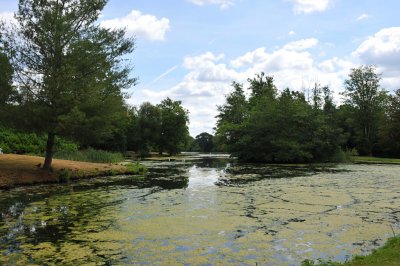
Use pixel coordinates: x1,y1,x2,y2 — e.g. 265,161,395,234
0,0,194,170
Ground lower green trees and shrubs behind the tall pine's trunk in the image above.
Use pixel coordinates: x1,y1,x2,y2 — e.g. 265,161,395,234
0,98,190,157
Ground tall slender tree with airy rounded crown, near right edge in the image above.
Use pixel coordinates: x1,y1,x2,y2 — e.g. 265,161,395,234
344,66,387,155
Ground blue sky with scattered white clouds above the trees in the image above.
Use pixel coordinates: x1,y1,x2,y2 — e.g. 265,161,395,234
0,0,400,136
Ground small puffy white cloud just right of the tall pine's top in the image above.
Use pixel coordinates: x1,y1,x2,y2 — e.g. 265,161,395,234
100,10,170,41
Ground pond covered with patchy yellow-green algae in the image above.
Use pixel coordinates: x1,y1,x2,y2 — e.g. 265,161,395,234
0,156,400,265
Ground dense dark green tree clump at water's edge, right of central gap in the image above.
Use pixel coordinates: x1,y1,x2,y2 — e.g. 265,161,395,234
217,74,343,163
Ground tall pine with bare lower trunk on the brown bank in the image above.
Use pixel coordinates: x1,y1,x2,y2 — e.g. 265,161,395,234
0,0,135,169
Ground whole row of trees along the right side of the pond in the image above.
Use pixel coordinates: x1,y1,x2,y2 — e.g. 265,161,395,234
216,66,400,163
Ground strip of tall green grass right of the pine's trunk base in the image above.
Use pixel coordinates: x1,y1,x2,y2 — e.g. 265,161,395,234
54,148,124,163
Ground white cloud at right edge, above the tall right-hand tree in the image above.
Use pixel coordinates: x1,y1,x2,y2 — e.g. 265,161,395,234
352,27,400,89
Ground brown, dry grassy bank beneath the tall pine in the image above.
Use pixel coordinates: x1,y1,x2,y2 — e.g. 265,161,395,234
0,154,146,188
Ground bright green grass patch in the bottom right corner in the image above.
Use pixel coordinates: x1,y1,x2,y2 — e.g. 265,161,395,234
302,237,400,266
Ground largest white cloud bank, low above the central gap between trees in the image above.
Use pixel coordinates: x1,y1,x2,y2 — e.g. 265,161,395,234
136,38,354,136
